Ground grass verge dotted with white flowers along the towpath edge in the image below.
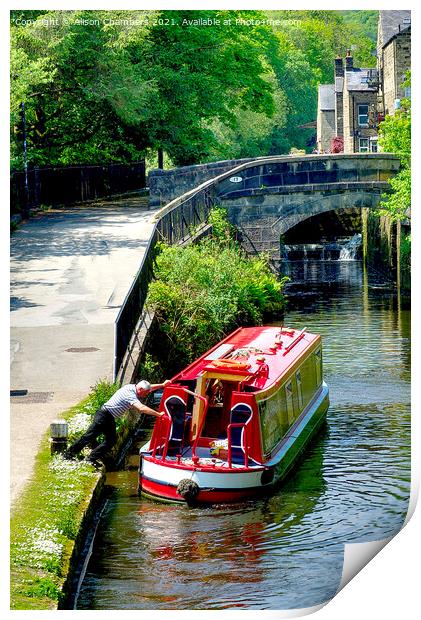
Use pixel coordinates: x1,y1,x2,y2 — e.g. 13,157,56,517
10,381,133,610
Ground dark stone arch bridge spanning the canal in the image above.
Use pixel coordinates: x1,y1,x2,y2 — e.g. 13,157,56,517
149,153,399,258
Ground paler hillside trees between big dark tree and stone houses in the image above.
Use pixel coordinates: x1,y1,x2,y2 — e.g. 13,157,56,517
266,10,375,153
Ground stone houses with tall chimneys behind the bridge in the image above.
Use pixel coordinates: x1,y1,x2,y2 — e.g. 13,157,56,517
317,11,411,153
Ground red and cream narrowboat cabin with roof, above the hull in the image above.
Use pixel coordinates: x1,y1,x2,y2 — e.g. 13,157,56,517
148,327,322,469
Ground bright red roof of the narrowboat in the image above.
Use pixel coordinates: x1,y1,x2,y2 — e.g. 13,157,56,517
173,327,320,390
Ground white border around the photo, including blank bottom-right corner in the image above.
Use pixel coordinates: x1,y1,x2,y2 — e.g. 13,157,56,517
0,0,421,620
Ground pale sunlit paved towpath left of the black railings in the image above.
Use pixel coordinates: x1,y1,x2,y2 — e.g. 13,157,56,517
10,196,158,503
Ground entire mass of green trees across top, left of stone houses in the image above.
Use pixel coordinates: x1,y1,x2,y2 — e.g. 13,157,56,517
11,10,378,169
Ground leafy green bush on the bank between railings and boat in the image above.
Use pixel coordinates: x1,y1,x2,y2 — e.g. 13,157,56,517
148,209,284,375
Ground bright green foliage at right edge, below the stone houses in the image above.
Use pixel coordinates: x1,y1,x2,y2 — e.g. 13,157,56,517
379,72,411,221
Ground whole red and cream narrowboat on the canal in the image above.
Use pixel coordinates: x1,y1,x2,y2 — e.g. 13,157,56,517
139,326,329,504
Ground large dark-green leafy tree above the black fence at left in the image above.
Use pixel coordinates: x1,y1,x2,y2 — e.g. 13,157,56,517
11,11,274,170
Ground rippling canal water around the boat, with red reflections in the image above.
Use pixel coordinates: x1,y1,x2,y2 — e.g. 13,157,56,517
77,261,410,610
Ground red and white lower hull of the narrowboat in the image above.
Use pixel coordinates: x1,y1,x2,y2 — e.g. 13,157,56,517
139,383,329,504
